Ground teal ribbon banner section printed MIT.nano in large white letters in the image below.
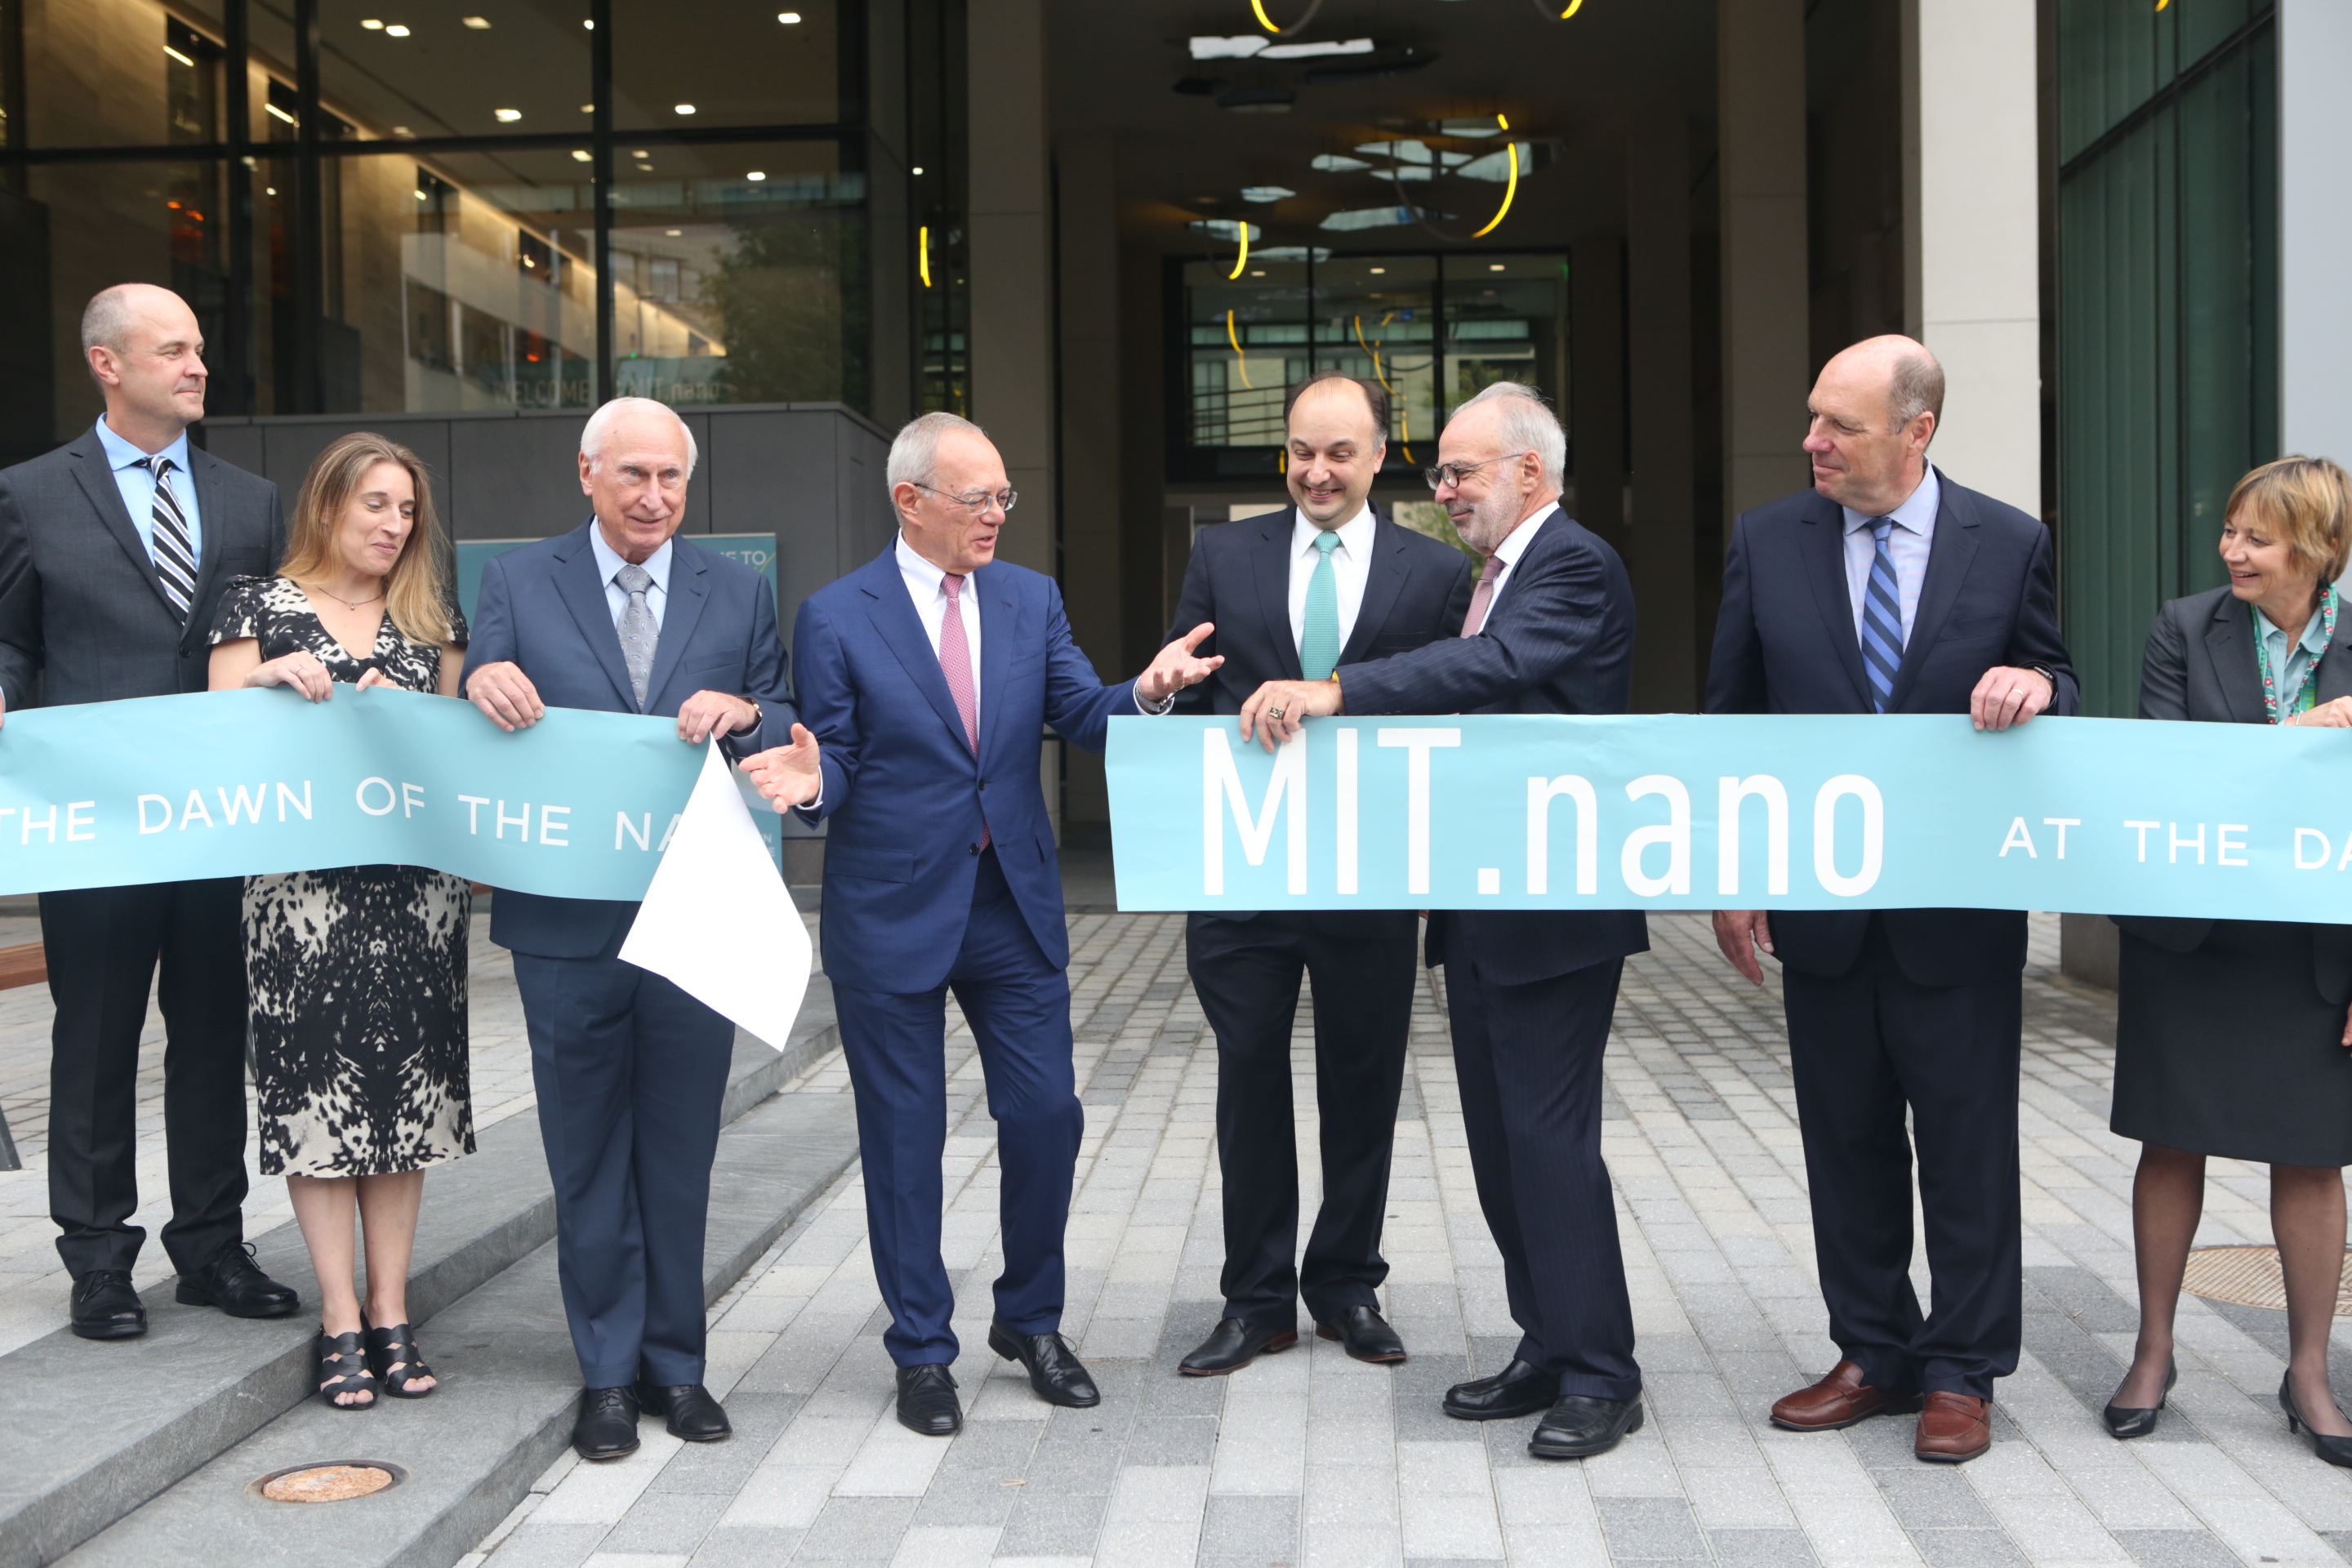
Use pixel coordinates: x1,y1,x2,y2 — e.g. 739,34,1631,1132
1105,715,2352,921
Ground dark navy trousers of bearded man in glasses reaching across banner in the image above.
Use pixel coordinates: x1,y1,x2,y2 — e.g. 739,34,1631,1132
1446,957,1642,1399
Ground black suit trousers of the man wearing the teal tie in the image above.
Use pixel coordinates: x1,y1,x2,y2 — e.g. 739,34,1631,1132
1186,912,1416,1328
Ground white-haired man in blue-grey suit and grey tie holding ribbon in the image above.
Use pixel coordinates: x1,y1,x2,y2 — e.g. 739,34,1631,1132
466,397,804,1460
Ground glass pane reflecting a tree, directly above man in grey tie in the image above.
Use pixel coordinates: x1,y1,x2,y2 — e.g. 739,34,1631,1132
612,141,872,409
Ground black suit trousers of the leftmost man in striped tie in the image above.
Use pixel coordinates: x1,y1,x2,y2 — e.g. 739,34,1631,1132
40,877,245,1276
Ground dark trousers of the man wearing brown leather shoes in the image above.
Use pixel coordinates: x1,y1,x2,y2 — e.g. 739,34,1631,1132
1783,920,2023,1399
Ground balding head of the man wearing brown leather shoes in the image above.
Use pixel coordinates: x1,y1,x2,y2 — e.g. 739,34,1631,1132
1804,334,1943,517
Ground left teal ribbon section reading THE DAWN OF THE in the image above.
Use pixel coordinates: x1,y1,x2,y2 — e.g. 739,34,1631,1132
0,687,706,898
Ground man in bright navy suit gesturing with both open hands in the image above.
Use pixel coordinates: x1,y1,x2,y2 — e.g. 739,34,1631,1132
743,414,1218,1437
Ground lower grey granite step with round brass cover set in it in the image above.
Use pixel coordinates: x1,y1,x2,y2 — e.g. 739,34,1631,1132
64,1091,858,1568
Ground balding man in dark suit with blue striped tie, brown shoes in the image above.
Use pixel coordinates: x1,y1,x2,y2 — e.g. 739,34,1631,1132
1708,336,2077,1464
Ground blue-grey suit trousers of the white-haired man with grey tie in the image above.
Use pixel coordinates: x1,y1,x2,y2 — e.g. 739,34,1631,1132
515,952,734,1389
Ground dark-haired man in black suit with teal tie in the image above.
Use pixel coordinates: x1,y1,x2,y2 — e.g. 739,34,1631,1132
1169,372,1470,1378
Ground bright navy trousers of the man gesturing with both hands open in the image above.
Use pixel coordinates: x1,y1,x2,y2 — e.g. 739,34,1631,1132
833,849,1087,1365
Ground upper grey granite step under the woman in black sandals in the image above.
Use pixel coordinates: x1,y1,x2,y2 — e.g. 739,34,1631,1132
0,976,847,1568
